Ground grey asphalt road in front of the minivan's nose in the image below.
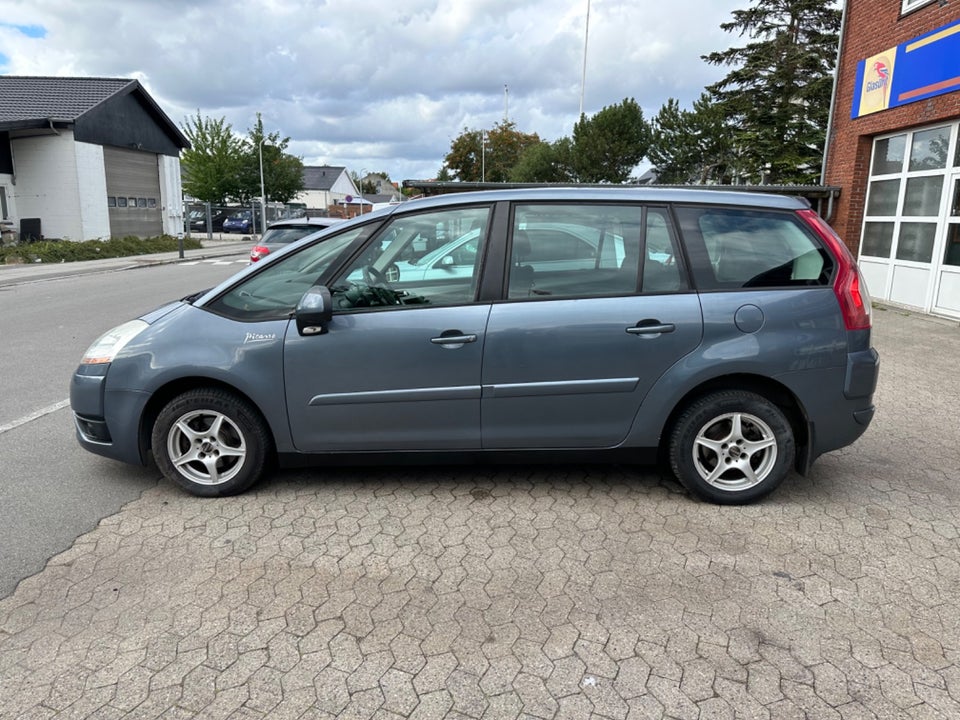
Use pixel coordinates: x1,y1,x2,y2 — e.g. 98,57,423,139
0,255,248,597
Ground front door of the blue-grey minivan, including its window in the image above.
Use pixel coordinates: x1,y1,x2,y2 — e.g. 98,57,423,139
284,206,490,452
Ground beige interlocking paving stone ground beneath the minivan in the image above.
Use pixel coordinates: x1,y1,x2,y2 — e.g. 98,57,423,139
0,309,960,720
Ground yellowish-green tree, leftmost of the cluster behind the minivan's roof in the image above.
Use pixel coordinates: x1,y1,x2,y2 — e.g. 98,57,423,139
444,121,540,182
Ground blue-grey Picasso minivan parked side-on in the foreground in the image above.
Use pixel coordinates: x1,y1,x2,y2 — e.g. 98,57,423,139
70,188,879,503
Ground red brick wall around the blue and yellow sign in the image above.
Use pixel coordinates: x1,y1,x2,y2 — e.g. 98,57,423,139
825,0,960,253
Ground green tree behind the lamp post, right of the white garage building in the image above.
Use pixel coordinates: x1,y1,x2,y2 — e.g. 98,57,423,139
240,113,303,204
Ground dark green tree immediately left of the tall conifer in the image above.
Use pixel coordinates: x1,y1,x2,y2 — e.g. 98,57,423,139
647,93,733,185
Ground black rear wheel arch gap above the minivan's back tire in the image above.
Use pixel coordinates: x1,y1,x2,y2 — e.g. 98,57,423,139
660,373,812,475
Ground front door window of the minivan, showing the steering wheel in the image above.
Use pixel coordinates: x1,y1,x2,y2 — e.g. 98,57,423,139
330,206,490,312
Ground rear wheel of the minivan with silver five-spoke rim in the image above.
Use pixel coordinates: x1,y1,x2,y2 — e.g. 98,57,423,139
670,390,796,505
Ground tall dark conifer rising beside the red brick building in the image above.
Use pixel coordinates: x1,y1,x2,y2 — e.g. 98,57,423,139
703,0,841,184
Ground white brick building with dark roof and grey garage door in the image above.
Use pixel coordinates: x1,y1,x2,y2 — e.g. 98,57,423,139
0,76,190,240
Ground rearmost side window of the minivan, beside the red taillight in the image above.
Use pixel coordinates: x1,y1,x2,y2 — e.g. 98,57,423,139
677,207,834,290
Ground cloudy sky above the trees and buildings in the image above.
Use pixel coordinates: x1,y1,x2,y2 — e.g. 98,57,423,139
0,0,751,180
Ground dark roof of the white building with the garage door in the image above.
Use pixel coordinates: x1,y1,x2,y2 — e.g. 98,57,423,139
0,75,190,147
